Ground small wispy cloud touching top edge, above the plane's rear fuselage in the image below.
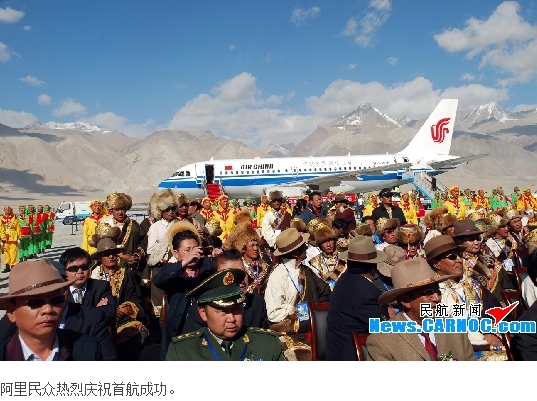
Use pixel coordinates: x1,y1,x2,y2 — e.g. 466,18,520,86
341,0,392,47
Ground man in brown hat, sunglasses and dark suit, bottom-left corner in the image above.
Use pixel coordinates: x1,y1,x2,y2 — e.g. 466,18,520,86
0,259,103,361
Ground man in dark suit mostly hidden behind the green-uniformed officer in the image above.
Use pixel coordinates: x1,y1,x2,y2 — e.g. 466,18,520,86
182,249,268,333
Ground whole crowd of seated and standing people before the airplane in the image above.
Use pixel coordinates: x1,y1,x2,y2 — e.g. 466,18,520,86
0,186,537,361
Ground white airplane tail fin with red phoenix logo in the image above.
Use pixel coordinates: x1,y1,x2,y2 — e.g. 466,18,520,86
399,99,459,155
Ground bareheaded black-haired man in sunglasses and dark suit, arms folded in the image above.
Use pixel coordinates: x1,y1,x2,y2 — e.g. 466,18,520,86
60,247,116,326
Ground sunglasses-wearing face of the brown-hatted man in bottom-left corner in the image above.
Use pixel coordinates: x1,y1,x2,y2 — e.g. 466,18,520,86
7,289,66,342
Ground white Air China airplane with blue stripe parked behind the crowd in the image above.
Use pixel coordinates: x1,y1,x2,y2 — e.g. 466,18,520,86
158,99,486,198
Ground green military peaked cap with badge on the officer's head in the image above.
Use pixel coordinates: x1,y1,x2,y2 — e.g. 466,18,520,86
186,269,246,308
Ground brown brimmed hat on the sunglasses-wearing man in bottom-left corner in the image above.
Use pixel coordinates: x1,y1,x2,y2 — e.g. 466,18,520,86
0,259,75,309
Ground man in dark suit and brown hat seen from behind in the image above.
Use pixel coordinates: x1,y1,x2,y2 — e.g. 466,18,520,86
326,235,388,361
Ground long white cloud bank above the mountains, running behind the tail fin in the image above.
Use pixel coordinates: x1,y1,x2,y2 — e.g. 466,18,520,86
167,72,508,145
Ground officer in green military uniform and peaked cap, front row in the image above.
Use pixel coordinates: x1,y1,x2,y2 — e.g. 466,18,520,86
166,269,284,361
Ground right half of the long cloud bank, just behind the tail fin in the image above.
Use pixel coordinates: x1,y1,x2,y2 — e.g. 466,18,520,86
306,77,508,123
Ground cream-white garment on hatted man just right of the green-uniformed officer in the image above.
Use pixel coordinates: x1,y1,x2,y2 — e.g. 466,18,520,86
265,259,300,323
